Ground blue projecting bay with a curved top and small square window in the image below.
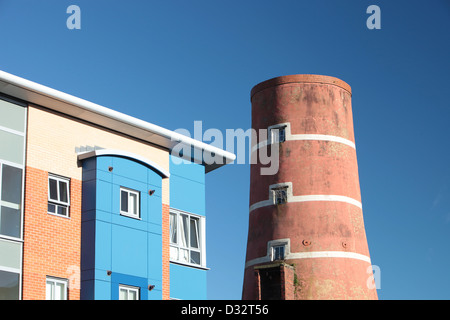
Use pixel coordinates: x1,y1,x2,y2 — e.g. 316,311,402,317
81,156,162,300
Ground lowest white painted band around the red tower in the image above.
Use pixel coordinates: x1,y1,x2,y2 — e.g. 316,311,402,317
245,251,371,268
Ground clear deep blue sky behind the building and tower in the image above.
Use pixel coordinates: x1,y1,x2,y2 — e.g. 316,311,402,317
0,0,450,299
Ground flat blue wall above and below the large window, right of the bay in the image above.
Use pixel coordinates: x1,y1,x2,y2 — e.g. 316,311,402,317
170,156,207,300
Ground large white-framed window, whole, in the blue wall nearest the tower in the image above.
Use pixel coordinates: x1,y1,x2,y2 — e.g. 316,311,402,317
170,211,205,266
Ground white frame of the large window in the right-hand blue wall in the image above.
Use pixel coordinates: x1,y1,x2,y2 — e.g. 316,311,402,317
169,208,206,268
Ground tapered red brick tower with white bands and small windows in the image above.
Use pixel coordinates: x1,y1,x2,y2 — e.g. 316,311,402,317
242,75,377,300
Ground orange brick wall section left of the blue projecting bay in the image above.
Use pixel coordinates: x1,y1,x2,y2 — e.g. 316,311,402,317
22,167,81,300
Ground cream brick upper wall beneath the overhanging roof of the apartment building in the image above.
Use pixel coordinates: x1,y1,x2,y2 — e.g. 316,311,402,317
26,105,169,204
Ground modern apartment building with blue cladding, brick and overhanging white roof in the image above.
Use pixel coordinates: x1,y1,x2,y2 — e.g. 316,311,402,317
0,71,235,300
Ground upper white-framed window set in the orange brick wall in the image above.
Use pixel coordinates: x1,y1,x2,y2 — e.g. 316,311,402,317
47,175,70,217
